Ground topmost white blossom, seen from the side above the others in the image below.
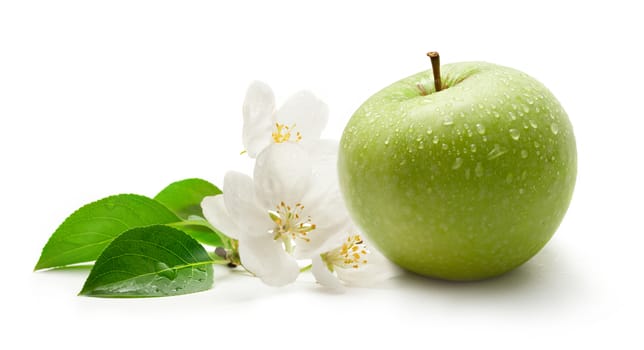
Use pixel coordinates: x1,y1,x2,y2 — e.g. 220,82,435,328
242,81,329,158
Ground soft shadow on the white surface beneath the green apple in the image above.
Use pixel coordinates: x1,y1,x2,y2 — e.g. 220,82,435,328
382,245,587,312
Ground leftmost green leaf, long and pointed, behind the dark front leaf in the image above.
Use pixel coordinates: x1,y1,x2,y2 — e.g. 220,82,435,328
35,194,180,270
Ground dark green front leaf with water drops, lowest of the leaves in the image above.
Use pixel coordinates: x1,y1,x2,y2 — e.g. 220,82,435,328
80,225,213,297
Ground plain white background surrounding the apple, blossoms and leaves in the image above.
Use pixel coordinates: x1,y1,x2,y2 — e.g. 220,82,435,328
0,0,644,349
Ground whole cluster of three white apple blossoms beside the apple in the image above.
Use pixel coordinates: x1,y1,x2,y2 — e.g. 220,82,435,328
201,82,396,288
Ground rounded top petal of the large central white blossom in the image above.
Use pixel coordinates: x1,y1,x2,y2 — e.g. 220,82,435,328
254,143,311,210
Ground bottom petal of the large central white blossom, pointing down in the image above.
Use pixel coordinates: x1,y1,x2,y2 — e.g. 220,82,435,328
239,232,300,287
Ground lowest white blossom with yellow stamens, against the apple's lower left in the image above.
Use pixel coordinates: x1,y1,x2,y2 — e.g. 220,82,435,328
311,229,399,289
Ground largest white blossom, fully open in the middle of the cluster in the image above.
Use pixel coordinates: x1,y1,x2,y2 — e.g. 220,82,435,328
201,141,349,286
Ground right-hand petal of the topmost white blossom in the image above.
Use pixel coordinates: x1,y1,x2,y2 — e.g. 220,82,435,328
275,91,329,142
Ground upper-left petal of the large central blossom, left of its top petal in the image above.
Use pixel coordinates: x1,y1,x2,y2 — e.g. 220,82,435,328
224,171,273,236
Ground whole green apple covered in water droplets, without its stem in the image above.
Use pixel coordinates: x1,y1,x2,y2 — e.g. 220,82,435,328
338,62,577,281
